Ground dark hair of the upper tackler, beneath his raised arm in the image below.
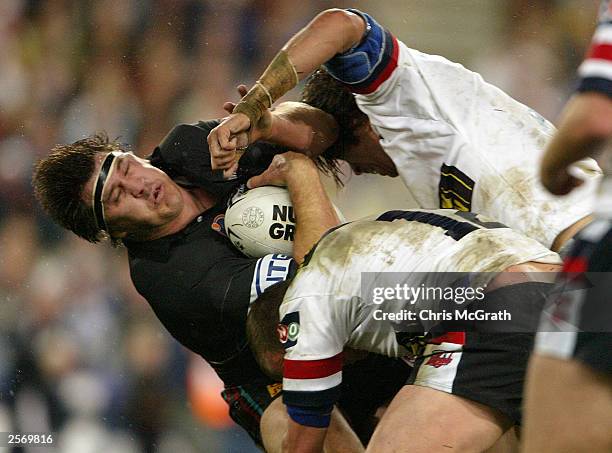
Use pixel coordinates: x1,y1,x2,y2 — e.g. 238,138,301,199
302,68,368,184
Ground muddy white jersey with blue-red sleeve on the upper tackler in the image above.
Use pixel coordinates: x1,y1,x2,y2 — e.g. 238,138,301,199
325,10,601,247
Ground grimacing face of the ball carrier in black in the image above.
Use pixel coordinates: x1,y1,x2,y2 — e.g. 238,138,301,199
83,153,184,237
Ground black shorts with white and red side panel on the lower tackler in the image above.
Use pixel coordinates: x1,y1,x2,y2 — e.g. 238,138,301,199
408,282,552,425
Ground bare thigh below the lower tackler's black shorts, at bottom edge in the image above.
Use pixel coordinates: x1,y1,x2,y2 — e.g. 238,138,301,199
367,385,511,453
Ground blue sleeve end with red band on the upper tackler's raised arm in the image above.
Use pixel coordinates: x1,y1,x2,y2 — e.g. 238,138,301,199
324,9,399,94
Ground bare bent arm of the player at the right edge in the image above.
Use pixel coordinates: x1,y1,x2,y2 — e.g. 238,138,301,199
540,92,612,195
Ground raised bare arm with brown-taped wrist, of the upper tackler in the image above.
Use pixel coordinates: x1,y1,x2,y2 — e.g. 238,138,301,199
208,9,366,173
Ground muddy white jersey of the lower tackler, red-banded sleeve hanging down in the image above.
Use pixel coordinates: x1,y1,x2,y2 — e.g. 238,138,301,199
280,210,560,406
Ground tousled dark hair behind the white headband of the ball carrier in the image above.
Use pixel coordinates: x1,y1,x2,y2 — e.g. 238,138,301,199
33,132,123,242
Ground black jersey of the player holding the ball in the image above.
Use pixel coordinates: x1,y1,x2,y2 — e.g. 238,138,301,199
126,121,293,385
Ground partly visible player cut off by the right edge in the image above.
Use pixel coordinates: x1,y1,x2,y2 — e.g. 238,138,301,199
523,0,612,453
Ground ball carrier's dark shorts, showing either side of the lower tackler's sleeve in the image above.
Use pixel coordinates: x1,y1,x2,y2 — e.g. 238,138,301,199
221,354,412,446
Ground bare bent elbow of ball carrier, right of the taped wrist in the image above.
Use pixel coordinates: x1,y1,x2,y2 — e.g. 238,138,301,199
266,102,338,157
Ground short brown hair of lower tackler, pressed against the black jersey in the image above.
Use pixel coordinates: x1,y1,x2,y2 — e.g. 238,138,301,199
246,279,292,378
